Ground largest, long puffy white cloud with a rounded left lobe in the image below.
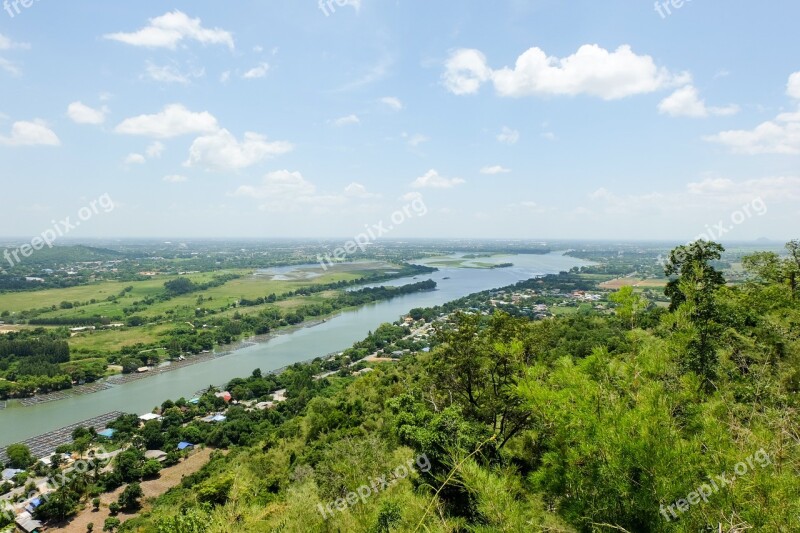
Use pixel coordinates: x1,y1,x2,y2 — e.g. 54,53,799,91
442,44,689,100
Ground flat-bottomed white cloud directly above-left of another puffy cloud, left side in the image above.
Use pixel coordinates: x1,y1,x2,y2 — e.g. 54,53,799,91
114,104,219,139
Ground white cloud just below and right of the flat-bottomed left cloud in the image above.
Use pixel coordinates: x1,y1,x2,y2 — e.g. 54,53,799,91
185,129,293,170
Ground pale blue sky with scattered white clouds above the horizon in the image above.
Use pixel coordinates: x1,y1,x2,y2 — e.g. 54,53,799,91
0,0,800,242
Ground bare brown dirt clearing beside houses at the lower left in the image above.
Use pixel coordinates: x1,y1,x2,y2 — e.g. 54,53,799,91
53,448,213,533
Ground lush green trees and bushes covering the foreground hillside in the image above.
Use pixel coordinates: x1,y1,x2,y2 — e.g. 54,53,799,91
98,242,800,533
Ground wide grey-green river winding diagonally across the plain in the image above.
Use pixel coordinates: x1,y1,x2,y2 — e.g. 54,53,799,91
0,253,588,446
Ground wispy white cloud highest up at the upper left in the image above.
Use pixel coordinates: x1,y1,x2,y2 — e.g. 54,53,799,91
104,10,234,50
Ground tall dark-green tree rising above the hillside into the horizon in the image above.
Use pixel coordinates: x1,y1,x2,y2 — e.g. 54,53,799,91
664,240,725,389
